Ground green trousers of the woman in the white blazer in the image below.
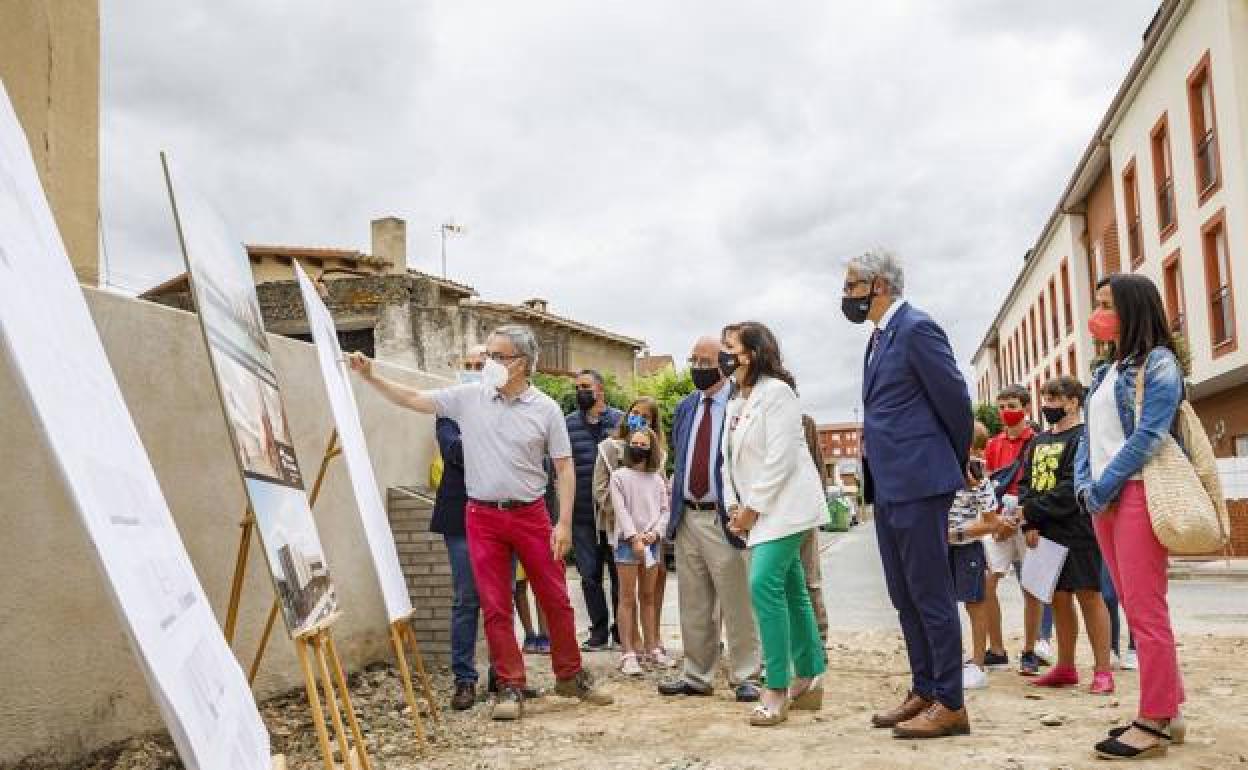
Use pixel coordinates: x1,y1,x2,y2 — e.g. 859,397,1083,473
750,532,827,690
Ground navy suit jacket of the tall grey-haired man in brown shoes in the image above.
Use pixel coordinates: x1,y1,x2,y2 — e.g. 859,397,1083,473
862,302,975,503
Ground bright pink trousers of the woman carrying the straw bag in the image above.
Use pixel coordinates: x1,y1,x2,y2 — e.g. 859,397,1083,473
1093,482,1186,719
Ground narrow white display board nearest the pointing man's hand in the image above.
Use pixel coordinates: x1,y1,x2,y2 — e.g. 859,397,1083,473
295,262,412,623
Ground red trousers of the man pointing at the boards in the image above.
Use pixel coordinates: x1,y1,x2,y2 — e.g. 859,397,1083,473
466,499,580,688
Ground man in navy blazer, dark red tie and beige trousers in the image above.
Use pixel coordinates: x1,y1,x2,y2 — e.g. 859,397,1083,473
659,337,761,701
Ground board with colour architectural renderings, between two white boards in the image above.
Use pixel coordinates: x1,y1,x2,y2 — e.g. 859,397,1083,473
166,155,337,636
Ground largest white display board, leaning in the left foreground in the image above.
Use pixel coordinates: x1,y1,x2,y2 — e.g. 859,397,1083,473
0,85,271,770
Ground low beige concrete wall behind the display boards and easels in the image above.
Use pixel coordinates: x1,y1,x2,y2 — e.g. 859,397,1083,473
0,290,438,763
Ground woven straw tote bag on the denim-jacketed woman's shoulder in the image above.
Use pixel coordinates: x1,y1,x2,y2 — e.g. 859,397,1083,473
1136,367,1228,555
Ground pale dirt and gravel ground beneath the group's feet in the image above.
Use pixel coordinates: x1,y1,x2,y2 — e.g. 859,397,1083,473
20,631,1248,770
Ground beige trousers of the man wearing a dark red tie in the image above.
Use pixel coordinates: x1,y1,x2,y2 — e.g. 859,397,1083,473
676,508,761,689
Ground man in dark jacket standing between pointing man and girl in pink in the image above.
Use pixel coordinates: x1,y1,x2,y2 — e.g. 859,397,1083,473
567,369,624,651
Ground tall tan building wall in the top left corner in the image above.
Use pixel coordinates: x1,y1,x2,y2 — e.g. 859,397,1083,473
0,0,100,286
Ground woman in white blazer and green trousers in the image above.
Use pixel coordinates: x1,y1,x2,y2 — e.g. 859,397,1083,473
721,321,827,726
